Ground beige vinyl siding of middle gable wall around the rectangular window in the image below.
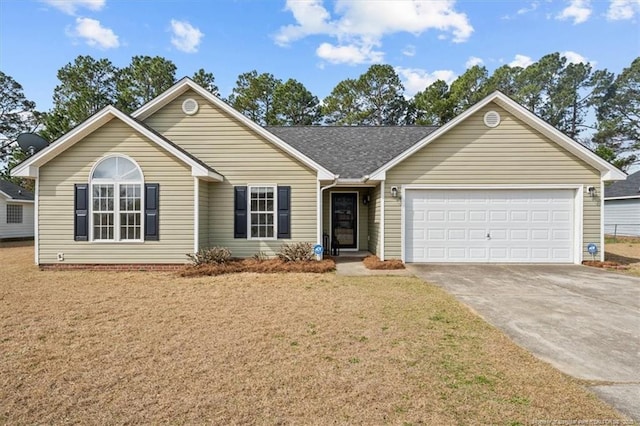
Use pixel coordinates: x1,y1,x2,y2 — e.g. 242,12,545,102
145,91,317,257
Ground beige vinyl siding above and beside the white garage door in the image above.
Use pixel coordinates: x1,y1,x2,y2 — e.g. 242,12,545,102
385,103,602,258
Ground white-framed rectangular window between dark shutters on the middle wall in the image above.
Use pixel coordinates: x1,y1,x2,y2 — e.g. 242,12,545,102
248,185,277,240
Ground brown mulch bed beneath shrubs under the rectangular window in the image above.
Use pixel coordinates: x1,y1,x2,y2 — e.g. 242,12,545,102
180,259,336,277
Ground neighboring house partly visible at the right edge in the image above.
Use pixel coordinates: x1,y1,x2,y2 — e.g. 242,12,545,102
604,170,640,237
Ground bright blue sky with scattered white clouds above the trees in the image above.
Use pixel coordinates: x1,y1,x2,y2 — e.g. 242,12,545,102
0,0,640,110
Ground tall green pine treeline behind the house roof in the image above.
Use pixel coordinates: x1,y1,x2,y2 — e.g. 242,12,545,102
0,53,640,184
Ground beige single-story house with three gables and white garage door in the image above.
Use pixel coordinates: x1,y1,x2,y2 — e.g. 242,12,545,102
12,78,625,267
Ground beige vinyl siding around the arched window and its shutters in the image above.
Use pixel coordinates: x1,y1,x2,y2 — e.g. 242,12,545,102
38,119,194,264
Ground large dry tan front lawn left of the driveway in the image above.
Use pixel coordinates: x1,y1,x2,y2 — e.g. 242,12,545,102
0,241,620,425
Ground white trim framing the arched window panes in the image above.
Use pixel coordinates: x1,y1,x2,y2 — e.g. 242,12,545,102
88,154,146,244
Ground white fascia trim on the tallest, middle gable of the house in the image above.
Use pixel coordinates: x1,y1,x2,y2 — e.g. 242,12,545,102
131,77,335,179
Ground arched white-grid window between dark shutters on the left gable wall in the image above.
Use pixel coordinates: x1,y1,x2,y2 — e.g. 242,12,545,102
90,155,144,241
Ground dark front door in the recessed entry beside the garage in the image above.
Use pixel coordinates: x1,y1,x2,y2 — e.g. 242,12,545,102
331,192,358,248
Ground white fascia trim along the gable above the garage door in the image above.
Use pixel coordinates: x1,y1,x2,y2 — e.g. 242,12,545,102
371,92,627,181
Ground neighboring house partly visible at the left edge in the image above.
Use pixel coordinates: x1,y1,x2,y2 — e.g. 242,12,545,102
0,180,33,241
